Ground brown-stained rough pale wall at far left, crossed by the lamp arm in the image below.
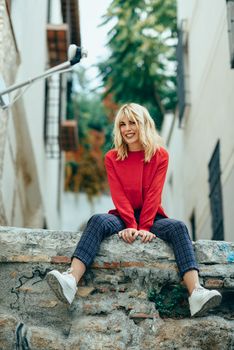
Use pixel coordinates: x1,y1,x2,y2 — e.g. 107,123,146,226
0,0,43,227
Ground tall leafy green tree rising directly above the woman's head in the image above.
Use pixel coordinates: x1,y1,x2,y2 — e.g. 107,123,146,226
99,0,177,127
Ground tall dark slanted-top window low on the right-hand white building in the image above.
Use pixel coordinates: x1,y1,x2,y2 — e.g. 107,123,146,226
208,141,224,240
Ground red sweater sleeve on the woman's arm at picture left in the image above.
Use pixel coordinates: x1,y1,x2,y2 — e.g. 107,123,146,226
105,155,137,229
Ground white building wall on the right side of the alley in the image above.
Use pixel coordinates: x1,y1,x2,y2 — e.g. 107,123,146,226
163,0,234,240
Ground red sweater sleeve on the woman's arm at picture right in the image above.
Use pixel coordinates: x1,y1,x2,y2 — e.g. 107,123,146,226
138,148,169,231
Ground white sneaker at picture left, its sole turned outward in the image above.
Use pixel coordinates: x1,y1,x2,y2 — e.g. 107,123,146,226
46,269,77,304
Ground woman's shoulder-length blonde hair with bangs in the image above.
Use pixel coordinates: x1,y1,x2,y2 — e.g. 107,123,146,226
113,103,163,162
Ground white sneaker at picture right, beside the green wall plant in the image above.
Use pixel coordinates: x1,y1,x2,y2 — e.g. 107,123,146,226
189,286,222,316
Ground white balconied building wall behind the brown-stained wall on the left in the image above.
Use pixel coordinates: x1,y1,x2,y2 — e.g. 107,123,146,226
8,0,66,229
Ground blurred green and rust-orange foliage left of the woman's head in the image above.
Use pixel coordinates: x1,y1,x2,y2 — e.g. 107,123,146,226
65,66,111,201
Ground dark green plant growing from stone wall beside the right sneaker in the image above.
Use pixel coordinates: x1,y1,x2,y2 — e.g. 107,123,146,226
148,285,190,318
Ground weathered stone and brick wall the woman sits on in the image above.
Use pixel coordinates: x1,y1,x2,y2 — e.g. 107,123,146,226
0,227,234,350
